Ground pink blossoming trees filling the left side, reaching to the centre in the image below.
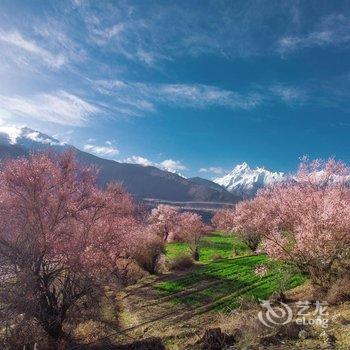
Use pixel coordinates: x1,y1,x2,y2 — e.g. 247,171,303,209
0,152,205,339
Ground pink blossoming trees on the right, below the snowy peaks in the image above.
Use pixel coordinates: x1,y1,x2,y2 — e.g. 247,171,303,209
213,159,350,295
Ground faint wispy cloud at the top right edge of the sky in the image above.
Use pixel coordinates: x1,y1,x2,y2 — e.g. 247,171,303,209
277,14,350,54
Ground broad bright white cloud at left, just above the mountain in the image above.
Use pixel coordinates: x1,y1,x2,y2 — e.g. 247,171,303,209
0,90,100,126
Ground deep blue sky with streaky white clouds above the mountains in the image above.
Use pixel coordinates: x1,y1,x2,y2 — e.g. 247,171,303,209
0,0,350,178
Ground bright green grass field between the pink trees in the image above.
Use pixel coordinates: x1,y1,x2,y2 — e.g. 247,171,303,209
155,232,305,310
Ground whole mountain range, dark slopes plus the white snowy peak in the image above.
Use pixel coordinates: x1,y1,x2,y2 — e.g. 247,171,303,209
0,127,285,205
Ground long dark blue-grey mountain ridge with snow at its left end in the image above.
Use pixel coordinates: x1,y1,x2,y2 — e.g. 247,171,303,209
0,127,240,203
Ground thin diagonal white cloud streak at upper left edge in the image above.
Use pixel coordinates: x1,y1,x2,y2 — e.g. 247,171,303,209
0,30,65,68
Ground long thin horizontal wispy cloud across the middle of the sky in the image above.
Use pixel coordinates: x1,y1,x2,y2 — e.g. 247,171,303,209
92,80,310,116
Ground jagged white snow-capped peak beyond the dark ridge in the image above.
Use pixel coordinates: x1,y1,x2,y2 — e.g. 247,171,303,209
213,163,284,198
